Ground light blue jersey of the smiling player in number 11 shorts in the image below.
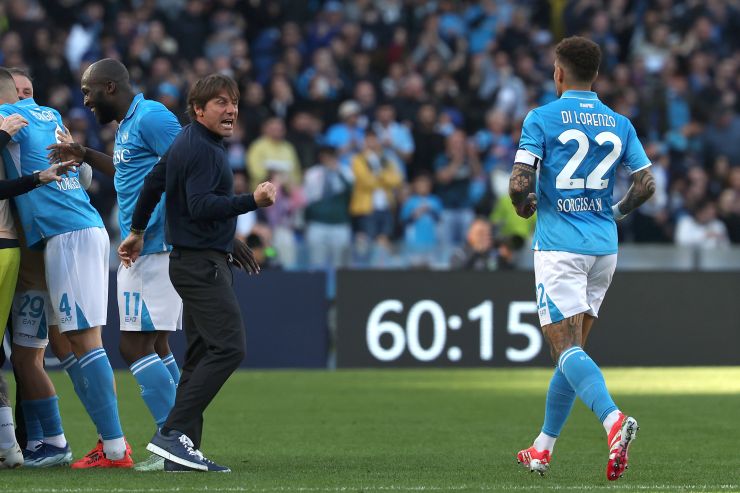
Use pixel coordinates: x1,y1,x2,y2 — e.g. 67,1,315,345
113,94,180,255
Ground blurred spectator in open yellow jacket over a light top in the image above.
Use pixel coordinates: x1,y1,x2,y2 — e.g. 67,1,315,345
349,130,403,246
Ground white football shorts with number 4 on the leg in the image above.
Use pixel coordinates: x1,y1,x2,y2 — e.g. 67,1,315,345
44,228,110,333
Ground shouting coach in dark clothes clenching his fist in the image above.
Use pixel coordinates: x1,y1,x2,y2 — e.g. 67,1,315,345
118,74,276,472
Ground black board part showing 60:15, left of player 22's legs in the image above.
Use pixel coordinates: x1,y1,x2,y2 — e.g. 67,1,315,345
337,271,551,367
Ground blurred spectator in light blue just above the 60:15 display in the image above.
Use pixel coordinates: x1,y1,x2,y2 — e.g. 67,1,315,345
399,172,442,265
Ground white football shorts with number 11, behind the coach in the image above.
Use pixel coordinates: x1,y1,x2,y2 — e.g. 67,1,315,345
117,252,182,332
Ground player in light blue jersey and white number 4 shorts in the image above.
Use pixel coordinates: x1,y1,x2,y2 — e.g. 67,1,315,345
0,67,133,467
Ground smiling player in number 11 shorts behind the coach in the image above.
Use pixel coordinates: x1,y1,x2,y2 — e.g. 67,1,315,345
51,58,182,470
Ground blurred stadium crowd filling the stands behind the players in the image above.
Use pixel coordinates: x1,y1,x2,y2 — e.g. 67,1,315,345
0,0,740,268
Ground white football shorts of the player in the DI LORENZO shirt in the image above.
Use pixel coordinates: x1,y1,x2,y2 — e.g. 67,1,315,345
534,250,617,327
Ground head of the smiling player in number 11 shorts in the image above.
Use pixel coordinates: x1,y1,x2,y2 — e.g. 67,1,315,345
80,58,133,124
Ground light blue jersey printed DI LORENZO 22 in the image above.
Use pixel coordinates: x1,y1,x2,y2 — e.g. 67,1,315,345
515,91,651,255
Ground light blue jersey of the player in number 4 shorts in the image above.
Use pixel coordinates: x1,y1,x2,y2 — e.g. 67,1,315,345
0,98,104,247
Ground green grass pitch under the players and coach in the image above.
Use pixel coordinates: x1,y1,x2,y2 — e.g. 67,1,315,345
0,368,740,493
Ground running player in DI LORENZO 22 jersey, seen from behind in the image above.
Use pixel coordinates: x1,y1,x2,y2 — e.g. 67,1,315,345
509,37,655,480
